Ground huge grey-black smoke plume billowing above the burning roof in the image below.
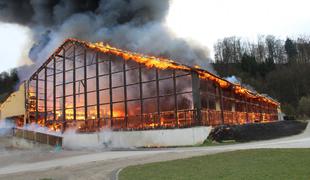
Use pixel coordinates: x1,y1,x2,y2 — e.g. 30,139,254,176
0,0,210,80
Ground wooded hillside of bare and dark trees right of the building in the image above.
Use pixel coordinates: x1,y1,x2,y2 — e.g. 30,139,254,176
214,35,310,118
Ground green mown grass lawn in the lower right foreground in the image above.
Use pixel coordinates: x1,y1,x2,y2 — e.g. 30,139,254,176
120,149,310,180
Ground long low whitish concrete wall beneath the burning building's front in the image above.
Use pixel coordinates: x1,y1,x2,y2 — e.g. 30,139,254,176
63,126,211,149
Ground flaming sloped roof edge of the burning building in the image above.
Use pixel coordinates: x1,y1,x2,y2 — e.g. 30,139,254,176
32,38,279,106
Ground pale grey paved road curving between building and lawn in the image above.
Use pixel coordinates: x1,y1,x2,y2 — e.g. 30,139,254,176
0,125,310,179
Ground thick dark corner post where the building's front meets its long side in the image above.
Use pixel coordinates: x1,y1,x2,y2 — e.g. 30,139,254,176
191,71,201,125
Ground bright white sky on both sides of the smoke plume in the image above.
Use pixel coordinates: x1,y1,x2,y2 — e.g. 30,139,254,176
0,0,310,72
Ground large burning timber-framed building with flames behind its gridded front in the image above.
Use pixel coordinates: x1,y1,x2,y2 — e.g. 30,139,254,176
1,39,279,132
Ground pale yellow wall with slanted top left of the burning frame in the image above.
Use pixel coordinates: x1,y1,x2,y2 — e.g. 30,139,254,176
0,84,25,120
